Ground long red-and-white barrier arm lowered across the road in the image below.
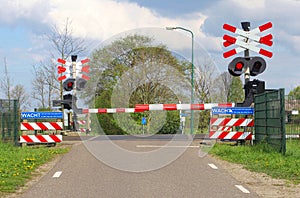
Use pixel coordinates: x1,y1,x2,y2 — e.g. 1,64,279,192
82,103,234,113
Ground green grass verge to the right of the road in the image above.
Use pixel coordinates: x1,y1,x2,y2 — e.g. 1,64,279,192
210,140,300,184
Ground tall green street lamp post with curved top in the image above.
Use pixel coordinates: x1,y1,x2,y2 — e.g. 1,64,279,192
166,27,194,134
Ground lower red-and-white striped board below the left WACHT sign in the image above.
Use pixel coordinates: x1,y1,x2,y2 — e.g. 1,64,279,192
19,135,62,143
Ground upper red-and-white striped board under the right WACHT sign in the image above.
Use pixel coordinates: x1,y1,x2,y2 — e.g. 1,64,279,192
210,118,254,127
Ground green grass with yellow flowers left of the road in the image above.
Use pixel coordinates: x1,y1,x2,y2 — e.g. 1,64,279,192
0,142,69,194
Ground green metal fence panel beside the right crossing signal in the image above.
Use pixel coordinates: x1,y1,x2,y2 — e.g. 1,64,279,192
254,89,286,154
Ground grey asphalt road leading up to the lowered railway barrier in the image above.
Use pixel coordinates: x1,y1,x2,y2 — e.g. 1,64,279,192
20,138,258,198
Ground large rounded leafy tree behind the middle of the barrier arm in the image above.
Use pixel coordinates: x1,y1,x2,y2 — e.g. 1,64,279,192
84,35,188,134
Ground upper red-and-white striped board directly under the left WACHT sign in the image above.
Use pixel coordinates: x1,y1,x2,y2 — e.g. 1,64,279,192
21,122,63,131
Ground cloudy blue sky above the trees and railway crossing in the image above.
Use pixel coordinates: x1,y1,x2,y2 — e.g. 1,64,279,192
0,0,300,98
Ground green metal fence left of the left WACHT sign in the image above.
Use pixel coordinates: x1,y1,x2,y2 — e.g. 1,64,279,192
0,99,20,144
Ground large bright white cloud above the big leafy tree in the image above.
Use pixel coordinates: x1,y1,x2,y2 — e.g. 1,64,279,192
48,0,203,39
